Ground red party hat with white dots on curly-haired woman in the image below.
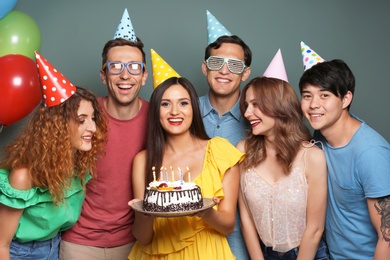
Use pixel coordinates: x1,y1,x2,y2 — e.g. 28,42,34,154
35,52,76,107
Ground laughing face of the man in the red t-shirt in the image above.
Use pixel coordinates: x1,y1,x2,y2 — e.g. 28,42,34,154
100,45,148,106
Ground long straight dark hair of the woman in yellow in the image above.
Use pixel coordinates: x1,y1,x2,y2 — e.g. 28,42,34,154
145,77,209,183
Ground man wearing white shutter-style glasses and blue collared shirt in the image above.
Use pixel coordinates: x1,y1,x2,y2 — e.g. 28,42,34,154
199,35,252,260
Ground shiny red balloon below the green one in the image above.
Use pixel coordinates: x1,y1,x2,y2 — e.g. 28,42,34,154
0,54,42,125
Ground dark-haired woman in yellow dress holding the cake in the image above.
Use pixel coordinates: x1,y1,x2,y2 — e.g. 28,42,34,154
129,77,243,260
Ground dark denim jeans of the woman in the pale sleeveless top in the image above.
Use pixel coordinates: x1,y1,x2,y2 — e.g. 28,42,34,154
261,238,330,260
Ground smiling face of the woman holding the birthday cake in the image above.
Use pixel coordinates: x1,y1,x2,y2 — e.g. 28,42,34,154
160,84,193,135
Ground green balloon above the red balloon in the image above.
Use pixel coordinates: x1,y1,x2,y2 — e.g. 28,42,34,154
0,10,41,60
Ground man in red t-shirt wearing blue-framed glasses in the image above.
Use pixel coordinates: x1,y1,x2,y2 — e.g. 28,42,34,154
60,38,149,260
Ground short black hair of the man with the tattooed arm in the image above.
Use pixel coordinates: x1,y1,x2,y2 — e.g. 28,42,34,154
299,59,355,110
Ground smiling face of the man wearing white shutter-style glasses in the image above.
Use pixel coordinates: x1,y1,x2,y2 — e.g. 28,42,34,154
202,43,250,98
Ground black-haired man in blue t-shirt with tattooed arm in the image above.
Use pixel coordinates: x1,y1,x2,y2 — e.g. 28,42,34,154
299,60,390,259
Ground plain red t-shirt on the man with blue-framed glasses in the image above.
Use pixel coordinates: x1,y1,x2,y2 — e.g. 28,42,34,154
62,97,149,247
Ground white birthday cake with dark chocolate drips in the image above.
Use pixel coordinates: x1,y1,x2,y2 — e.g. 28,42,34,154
143,180,203,212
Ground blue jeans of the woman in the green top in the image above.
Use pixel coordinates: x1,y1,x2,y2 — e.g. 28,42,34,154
10,234,61,260
